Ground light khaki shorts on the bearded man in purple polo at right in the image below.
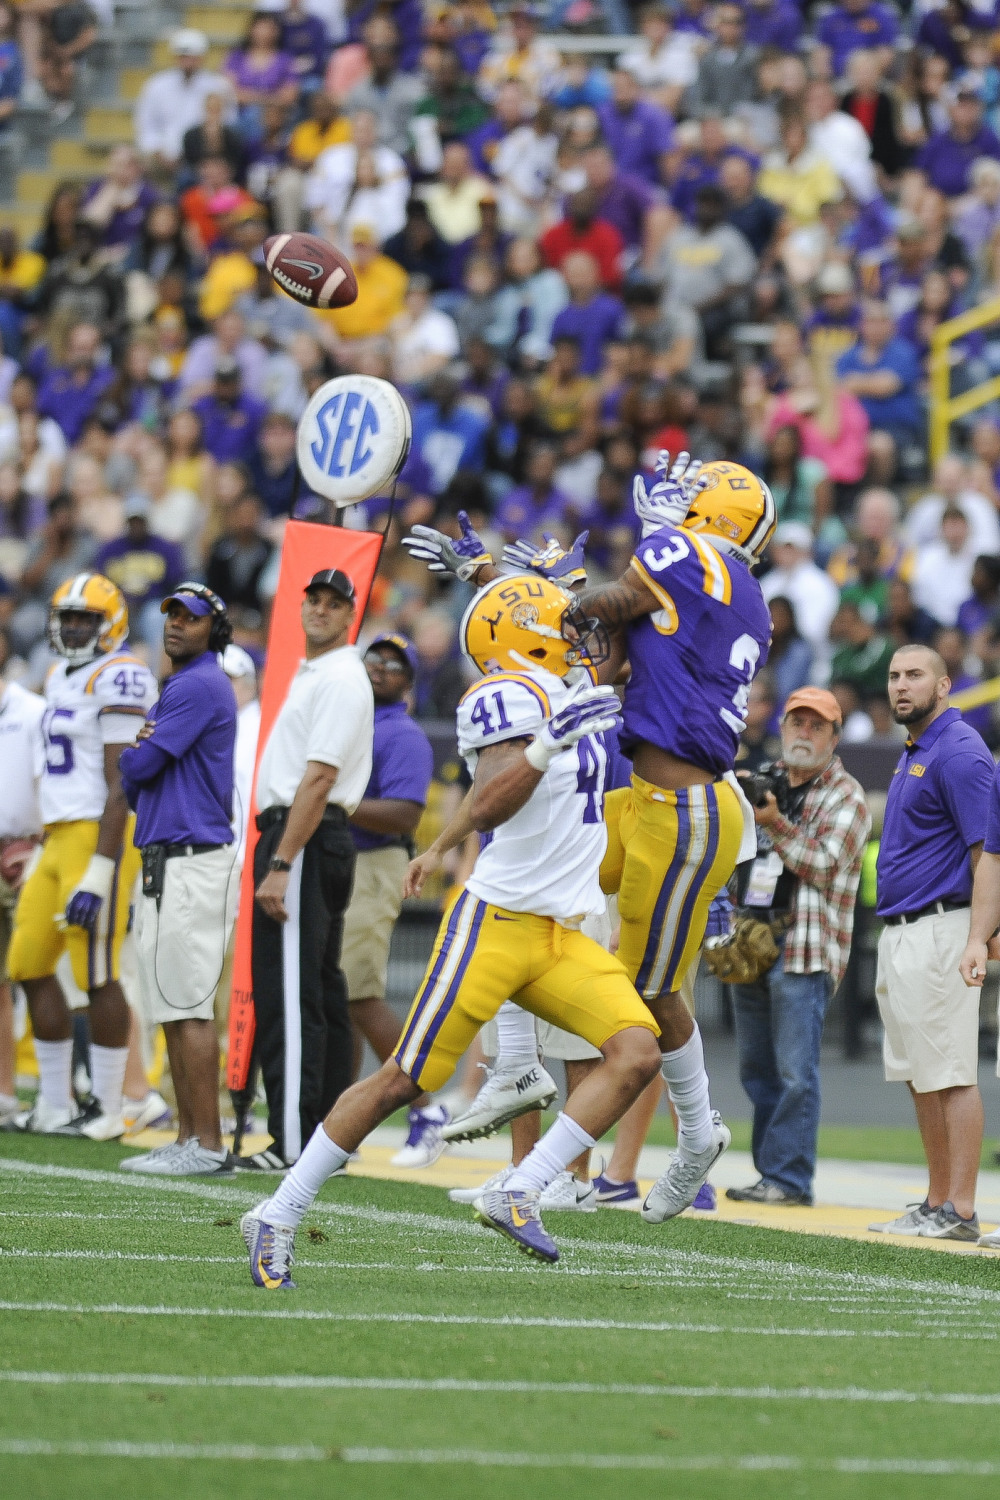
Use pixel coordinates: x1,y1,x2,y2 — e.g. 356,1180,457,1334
876,911,979,1094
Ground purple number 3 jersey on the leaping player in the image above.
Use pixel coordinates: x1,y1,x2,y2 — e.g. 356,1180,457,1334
621,527,771,777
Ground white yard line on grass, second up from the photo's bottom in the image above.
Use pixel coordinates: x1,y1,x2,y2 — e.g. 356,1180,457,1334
0,1370,1000,1407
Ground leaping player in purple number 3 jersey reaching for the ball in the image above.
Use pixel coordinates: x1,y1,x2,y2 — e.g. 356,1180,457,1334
403,453,777,1223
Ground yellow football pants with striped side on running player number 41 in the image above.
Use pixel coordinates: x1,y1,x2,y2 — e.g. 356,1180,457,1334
393,891,660,1092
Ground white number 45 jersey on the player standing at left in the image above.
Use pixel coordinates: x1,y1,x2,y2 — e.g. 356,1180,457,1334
39,651,159,827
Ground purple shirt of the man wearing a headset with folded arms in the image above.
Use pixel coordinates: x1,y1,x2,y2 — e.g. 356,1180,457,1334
120,651,237,849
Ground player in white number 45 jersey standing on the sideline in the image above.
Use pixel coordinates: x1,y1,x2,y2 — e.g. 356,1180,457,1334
9,573,157,1140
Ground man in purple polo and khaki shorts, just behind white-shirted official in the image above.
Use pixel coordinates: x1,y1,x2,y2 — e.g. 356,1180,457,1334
340,635,433,1079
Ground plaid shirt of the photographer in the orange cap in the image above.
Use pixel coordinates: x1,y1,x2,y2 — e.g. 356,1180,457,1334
768,756,871,990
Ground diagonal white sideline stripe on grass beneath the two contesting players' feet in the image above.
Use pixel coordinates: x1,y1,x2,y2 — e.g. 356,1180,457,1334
0,1157,1000,1304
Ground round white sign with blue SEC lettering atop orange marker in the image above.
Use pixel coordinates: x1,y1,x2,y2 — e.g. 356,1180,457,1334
295,375,411,506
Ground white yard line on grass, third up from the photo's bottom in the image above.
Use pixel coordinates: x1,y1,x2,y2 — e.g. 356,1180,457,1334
0,1302,1000,1343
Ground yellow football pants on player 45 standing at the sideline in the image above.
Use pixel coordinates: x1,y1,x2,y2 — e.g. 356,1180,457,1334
7,818,141,990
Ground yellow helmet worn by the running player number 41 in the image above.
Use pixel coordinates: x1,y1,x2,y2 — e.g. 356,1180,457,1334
459,573,610,677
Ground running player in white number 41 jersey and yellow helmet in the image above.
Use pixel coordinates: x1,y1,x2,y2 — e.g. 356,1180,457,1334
241,578,660,1290
